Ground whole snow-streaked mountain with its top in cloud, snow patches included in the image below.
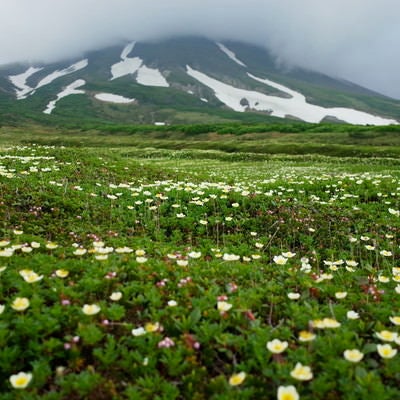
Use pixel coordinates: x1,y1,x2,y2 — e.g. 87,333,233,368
0,37,400,125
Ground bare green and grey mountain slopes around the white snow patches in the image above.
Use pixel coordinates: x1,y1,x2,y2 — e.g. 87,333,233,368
0,37,400,127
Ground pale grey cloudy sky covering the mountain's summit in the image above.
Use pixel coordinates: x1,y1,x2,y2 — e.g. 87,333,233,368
0,0,400,99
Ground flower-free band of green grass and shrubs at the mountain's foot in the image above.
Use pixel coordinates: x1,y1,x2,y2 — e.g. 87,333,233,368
0,122,400,159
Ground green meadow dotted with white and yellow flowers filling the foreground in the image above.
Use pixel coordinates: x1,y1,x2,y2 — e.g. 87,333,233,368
0,146,400,400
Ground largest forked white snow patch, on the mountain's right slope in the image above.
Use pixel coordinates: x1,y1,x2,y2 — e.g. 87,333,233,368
186,65,398,125
